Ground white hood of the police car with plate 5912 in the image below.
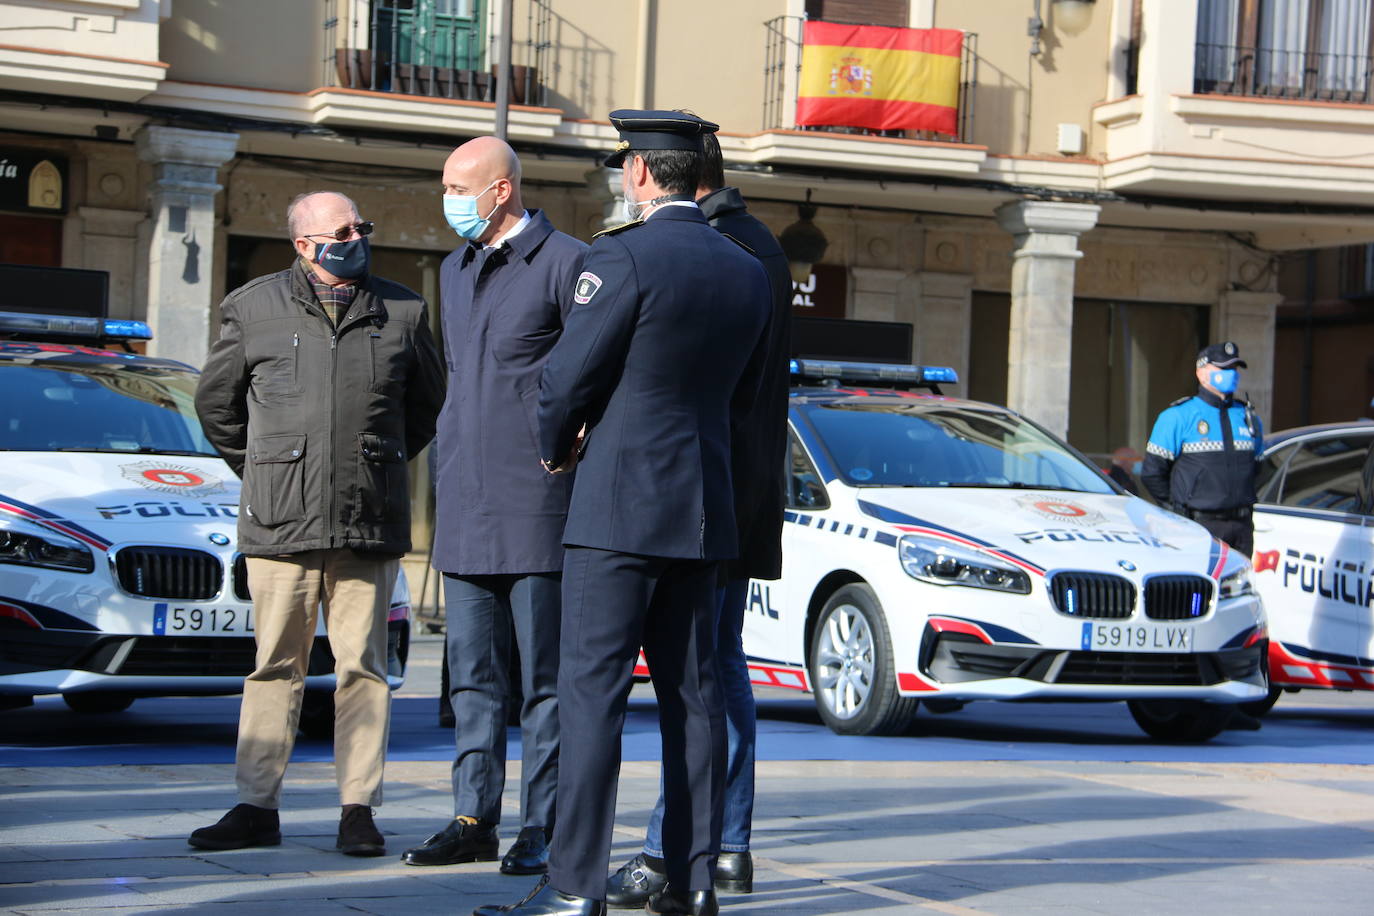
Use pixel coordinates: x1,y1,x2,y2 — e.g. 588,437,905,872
0,452,239,547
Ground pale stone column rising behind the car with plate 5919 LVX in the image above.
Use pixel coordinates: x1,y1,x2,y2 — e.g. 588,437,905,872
996,201,1101,437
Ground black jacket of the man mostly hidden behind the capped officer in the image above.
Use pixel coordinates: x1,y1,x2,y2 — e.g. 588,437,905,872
697,188,791,580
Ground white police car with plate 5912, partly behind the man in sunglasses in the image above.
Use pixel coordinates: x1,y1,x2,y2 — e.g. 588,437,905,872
0,313,409,732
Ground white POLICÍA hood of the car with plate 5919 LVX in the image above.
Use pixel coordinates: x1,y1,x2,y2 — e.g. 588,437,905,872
855,488,1245,578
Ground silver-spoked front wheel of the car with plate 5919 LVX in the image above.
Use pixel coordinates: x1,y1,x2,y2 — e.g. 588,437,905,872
809,582,919,735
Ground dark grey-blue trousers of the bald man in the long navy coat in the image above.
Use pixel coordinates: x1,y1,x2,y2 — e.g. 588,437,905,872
444,573,561,828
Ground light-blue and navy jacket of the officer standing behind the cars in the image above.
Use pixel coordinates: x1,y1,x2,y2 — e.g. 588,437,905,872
1140,389,1263,512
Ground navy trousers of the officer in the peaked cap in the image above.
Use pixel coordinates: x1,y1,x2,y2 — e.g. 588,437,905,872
548,547,725,900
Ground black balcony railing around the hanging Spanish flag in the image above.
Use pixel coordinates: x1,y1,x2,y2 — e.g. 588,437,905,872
763,16,978,143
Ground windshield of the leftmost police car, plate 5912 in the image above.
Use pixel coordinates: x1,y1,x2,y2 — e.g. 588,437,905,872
0,360,216,456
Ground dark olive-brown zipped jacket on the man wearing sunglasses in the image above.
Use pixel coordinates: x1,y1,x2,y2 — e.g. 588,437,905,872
195,264,444,556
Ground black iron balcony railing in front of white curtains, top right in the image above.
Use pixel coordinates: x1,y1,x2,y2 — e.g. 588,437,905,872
1193,44,1374,103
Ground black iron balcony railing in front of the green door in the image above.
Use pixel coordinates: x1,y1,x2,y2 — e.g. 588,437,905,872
324,0,551,106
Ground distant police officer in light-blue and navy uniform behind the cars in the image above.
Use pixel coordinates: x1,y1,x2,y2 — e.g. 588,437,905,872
1140,341,1261,556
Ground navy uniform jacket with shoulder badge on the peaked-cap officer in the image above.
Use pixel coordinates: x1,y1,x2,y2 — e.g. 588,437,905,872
539,205,771,560
